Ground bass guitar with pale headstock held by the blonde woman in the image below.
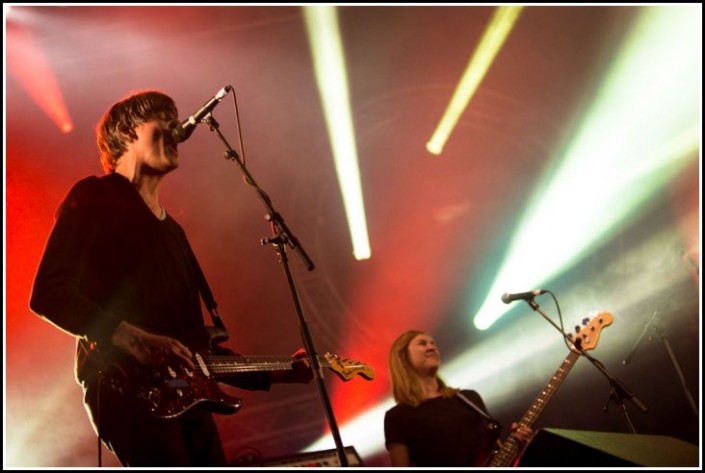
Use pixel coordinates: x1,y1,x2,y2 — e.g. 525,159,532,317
488,312,612,467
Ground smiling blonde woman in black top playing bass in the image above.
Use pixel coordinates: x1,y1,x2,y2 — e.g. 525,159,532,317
384,330,532,467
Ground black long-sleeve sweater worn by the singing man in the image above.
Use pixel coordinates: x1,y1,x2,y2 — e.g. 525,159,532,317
30,174,269,389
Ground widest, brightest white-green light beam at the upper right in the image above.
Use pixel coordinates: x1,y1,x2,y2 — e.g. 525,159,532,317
474,6,702,330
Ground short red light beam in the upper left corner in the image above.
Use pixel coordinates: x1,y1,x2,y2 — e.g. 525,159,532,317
6,22,73,133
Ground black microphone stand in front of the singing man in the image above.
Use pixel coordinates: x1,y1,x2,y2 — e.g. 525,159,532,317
203,113,349,467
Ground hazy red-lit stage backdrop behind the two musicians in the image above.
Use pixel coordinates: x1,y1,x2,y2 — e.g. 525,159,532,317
4,5,702,467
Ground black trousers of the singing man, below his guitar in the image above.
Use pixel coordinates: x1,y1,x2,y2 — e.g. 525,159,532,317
84,381,227,467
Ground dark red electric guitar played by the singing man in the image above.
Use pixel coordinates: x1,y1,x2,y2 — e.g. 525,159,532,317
99,327,375,419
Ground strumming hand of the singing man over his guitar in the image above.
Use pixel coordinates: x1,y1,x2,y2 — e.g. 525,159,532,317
110,321,194,369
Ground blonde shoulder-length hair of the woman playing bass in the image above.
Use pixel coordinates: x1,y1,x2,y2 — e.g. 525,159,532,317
389,330,458,407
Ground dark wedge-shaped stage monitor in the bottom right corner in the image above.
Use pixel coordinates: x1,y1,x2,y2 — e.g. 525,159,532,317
518,429,699,467
